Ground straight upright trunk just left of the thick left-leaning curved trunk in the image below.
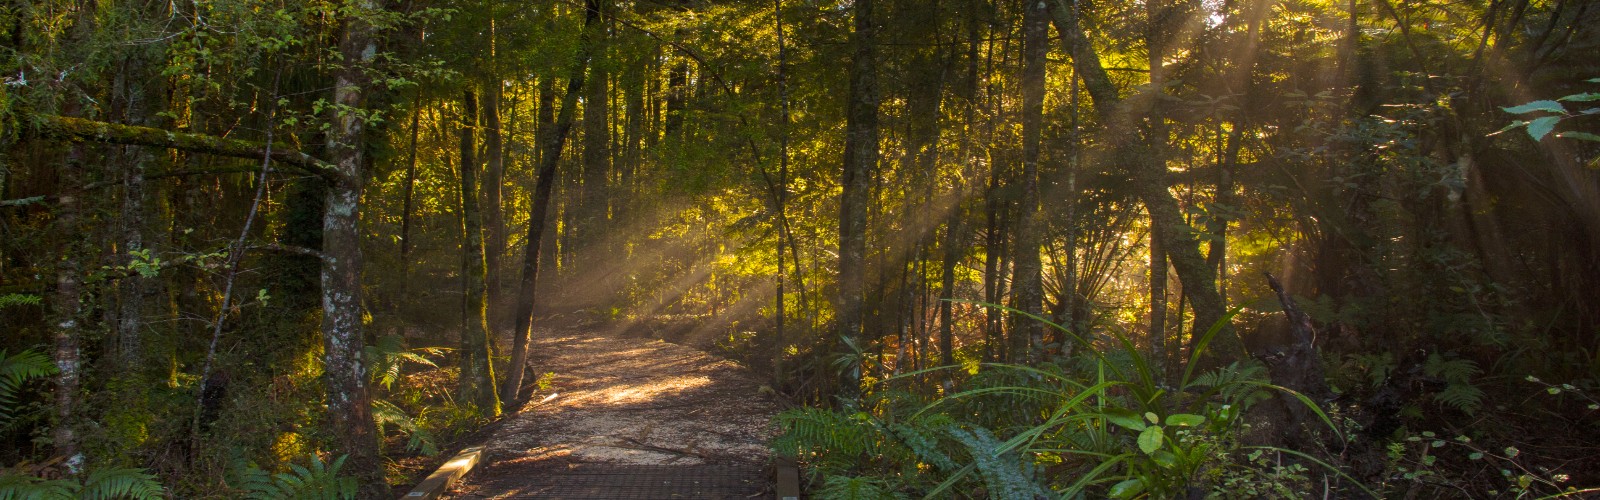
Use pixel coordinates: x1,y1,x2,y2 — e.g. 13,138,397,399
1011,2,1050,362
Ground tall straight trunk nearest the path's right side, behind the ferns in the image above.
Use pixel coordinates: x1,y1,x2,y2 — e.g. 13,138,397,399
838,0,878,399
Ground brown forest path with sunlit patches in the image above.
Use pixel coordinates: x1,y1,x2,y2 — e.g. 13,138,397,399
451,329,778,500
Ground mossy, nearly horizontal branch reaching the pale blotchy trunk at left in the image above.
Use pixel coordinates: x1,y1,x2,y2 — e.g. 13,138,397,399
32,114,333,176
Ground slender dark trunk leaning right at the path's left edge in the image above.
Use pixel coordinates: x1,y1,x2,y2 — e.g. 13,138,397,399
501,0,600,401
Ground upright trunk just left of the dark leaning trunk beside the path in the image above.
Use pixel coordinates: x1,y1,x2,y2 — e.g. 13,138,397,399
458,90,499,417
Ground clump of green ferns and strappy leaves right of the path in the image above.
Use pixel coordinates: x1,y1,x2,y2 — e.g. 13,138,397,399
773,310,1338,498
